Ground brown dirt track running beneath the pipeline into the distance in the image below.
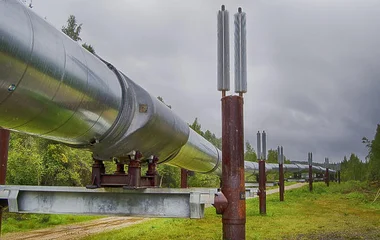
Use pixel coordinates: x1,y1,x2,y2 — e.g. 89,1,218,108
1,183,306,240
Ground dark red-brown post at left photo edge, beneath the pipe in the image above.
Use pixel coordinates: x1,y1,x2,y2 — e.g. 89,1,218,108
0,129,10,237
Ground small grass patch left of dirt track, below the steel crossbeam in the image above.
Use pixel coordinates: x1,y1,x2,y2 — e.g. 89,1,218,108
1,212,101,234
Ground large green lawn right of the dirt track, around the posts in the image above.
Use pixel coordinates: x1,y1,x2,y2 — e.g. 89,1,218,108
85,182,380,240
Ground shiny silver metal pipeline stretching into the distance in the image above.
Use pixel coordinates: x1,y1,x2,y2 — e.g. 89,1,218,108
0,0,334,176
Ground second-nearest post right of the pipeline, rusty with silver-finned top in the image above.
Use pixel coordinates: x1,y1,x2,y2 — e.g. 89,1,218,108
259,131,267,215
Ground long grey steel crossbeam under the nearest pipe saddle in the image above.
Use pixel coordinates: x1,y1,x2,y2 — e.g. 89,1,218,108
0,185,216,218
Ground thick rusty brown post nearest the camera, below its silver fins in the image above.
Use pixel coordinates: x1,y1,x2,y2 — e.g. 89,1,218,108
222,96,246,240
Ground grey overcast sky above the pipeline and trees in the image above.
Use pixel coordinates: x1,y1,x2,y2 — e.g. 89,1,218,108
29,0,380,162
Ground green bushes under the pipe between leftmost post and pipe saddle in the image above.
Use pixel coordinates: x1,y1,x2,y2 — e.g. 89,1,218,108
7,132,92,186
